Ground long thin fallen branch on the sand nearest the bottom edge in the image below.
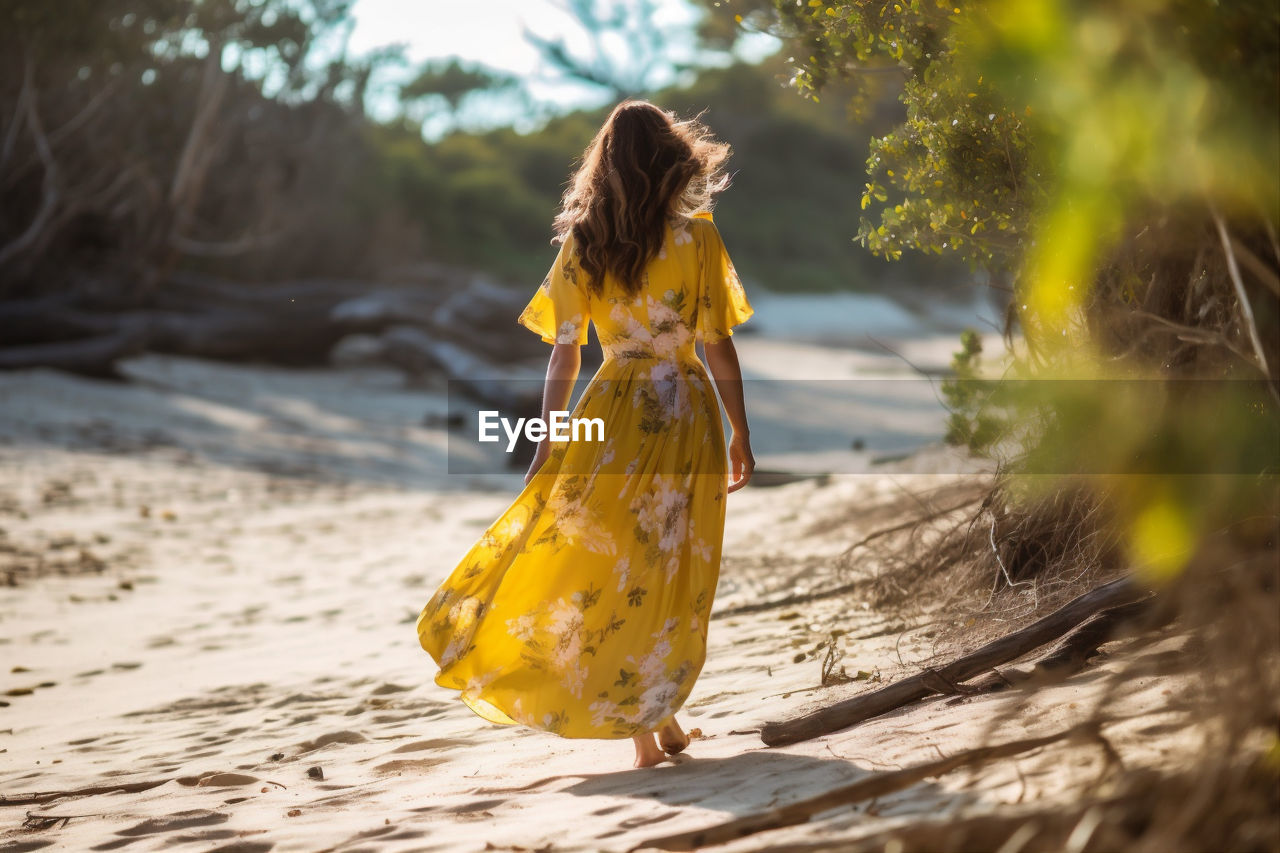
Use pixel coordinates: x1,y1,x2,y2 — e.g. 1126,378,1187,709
632,724,1097,850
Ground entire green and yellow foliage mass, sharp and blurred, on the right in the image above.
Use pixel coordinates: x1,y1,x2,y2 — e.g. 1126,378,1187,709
777,0,1280,579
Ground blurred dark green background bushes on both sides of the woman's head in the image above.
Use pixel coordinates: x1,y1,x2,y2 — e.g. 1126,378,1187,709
379,59,957,291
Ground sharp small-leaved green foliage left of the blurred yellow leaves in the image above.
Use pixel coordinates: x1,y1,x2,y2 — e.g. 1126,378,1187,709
778,0,1043,274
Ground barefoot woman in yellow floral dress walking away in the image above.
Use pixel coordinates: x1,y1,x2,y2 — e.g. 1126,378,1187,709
417,101,755,767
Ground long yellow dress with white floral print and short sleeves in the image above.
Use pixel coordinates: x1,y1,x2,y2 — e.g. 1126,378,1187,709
417,215,751,738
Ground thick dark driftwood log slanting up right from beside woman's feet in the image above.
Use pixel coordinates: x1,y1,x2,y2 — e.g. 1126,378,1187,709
760,576,1146,747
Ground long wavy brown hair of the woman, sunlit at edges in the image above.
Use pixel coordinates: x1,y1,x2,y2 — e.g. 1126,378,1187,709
553,100,730,296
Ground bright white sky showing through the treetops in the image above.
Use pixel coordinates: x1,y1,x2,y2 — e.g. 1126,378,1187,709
349,0,777,136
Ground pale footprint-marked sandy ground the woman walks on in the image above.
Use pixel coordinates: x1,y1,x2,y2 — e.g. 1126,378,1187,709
0,341,1198,852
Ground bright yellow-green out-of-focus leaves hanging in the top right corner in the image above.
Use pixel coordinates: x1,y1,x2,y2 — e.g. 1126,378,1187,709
957,0,1280,347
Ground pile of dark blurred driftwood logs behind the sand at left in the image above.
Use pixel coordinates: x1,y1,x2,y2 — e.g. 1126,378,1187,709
0,263,547,378
